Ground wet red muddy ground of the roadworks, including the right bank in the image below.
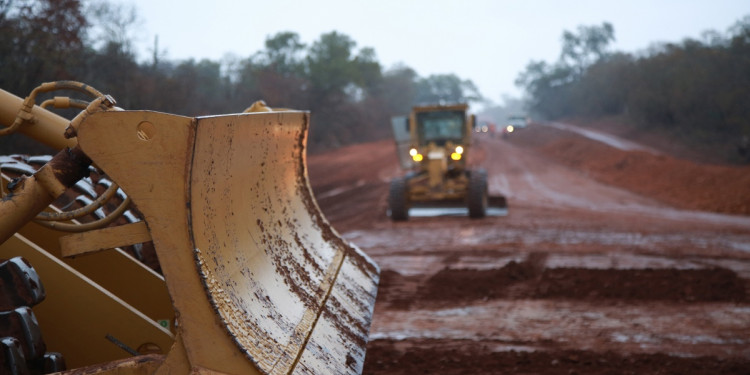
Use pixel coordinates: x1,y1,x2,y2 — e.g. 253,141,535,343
308,124,750,374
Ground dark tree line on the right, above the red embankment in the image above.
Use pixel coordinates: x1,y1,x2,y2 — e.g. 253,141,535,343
516,16,750,163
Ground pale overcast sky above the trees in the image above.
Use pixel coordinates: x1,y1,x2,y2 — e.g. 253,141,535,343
125,0,750,102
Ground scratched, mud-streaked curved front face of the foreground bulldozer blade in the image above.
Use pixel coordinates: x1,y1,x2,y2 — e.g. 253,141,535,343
190,112,378,374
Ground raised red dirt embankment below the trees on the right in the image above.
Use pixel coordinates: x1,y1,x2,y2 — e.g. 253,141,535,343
509,124,750,215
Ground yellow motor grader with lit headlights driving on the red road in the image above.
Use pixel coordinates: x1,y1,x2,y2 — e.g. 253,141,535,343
388,104,506,221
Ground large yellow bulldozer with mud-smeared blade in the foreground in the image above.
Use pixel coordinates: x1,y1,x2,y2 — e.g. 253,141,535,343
0,81,379,375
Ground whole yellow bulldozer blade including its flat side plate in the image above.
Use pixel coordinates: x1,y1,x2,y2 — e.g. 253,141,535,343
78,111,379,374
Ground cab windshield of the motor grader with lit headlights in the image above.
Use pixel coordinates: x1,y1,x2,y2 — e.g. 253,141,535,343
417,111,466,146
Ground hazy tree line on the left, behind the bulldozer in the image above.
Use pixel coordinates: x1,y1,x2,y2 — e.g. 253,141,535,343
0,0,482,153
